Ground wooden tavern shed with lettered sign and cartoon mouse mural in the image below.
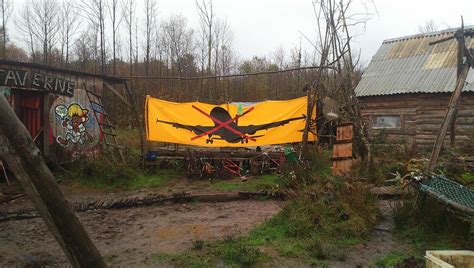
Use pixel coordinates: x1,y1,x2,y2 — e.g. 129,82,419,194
0,60,126,162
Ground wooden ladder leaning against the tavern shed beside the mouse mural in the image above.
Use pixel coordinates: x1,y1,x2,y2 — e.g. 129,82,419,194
84,85,125,162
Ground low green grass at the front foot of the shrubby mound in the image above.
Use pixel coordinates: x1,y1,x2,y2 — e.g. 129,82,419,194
241,192,366,263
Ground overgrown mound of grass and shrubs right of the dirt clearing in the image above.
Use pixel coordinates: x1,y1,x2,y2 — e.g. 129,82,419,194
226,150,378,265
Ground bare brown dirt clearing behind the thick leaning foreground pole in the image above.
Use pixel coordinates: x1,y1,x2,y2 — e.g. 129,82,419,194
0,200,281,267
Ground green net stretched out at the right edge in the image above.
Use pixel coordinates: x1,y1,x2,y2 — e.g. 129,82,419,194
419,175,474,218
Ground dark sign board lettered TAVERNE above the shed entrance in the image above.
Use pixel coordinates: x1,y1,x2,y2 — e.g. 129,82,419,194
0,68,75,97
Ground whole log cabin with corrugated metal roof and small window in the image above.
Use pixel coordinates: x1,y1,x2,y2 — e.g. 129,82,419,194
356,27,474,147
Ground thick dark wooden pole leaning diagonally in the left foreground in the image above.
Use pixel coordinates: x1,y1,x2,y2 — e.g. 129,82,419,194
0,96,105,267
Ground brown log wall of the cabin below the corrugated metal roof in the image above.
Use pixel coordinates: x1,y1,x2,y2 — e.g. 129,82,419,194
359,92,474,148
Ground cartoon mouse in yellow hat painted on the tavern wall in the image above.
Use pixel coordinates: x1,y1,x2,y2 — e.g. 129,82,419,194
55,103,93,146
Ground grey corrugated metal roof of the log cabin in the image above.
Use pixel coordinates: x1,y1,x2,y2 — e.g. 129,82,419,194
356,26,474,96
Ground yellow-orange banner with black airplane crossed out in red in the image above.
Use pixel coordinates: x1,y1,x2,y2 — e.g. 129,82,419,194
145,96,316,147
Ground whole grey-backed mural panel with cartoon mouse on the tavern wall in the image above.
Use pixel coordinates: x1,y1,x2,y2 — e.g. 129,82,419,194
50,89,101,155
